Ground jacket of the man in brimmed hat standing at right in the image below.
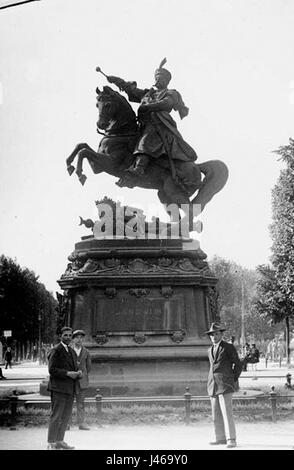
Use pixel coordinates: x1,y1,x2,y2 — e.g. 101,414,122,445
207,341,242,396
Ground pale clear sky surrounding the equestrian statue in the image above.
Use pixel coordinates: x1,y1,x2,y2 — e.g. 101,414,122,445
0,0,294,292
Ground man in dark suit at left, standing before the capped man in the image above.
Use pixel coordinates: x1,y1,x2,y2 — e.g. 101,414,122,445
47,326,82,450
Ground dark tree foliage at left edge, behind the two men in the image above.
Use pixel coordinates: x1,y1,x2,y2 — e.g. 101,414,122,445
0,255,57,342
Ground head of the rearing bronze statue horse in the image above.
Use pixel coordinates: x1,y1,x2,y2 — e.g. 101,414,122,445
96,86,136,130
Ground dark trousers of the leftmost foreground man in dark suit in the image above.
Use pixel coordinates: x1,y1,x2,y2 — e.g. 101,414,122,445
48,392,74,442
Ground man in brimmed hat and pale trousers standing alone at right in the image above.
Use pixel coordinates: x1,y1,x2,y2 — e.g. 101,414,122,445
206,323,242,448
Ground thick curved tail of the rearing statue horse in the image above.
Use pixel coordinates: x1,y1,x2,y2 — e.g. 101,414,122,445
191,160,229,212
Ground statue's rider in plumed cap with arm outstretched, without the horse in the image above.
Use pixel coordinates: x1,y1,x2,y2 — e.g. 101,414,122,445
107,59,197,177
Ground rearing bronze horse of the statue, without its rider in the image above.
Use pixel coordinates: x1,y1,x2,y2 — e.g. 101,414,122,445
66,86,228,230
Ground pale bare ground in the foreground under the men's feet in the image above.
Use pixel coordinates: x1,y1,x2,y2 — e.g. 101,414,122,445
0,422,294,451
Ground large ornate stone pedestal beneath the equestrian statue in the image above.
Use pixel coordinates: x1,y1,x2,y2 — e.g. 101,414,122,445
54,236,217,396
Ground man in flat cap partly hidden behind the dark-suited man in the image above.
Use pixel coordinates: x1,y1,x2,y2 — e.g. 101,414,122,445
72,330,91,431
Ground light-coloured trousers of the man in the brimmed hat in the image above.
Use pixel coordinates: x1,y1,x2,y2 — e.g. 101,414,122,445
210,393,236,441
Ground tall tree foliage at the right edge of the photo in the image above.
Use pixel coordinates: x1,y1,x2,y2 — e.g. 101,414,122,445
256,139,294,323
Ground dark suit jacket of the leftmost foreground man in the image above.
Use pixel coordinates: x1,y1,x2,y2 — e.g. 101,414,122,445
48,343,78,395
